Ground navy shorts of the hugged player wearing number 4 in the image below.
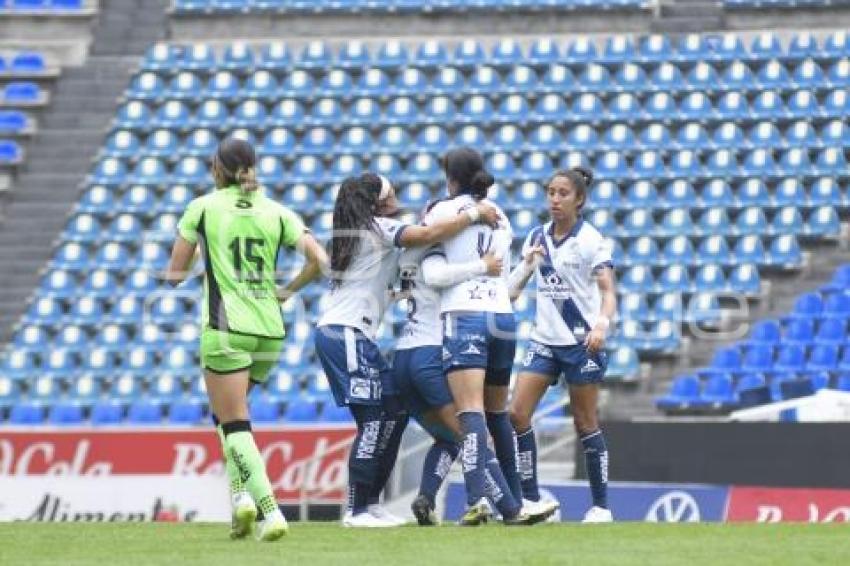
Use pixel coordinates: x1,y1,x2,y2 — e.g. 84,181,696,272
443,312,516,385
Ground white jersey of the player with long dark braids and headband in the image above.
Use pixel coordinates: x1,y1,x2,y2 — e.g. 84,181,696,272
319,218,407,340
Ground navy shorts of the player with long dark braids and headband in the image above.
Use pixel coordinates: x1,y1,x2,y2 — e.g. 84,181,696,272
315,325,396,407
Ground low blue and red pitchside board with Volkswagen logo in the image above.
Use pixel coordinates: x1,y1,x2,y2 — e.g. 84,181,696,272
443,481,850,523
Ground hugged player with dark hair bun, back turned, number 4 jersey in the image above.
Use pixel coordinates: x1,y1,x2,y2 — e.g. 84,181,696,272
422,148,530,525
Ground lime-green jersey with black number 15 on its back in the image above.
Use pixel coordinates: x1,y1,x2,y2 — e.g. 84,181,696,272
177,186,305,338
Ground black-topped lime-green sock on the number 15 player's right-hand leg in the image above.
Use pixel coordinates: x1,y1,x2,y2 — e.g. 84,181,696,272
222,421,278,517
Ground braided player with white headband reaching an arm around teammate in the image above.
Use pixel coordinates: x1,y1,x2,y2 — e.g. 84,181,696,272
315,173,499,527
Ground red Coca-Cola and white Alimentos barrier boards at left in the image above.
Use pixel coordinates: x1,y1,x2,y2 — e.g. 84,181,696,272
0,430,356,520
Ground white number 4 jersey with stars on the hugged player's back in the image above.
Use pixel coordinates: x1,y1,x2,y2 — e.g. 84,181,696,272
425,194,513,313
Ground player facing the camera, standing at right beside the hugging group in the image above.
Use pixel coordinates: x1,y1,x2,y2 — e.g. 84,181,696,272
510,168,617,523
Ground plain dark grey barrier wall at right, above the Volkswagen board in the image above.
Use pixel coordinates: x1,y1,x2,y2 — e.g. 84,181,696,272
576,421,850,488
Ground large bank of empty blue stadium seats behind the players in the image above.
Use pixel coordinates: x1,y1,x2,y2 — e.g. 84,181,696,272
0,30,850,422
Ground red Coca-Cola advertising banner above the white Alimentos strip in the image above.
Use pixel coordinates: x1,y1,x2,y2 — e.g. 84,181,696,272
0,425,356,502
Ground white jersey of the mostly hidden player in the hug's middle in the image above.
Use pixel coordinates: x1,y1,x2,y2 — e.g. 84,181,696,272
395,248,443,350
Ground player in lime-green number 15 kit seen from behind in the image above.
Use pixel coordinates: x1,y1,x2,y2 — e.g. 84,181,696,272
165,138,327,541
